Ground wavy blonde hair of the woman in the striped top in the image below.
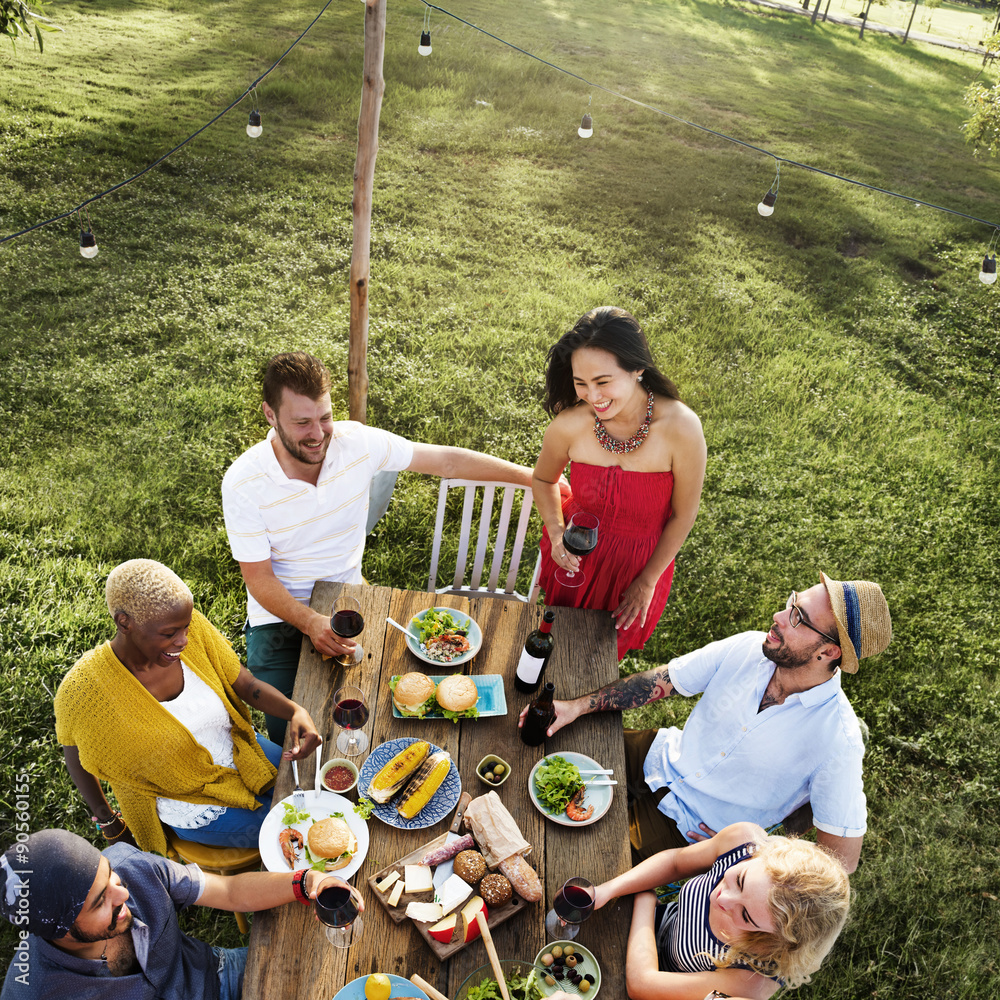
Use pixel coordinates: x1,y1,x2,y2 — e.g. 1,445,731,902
718,837,851,988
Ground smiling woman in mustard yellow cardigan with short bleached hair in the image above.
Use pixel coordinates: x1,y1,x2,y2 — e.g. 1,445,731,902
55,559,322,854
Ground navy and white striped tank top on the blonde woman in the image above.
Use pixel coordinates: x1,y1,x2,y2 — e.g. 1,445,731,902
656,843,754,972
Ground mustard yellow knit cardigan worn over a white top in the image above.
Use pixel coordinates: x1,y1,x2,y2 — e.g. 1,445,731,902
55,611,277,854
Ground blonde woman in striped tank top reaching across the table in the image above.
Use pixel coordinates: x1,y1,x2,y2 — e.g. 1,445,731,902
595,823,850,1000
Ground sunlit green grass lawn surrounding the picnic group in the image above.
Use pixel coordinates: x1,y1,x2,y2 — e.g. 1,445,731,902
0,0,1000,1000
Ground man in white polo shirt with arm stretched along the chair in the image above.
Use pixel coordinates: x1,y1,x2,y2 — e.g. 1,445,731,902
222,351,532,745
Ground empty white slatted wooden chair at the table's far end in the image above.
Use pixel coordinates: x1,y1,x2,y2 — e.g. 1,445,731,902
427,479,542,602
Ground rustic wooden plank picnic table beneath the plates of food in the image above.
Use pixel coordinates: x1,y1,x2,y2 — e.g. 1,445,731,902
243,583,631,1000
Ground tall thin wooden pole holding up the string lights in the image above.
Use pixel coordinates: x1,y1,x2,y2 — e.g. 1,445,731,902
347,0,386,423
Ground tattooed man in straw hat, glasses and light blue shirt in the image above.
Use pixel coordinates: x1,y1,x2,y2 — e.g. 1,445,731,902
522,573,892,872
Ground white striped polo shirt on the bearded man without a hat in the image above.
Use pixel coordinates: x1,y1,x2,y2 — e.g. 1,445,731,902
222,420,413,625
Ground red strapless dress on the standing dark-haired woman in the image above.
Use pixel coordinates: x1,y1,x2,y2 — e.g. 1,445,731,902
539,462,674,660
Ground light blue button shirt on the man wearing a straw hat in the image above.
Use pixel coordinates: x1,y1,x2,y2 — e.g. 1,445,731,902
643,632,867,837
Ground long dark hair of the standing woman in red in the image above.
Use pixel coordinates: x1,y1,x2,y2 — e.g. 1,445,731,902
544,306,681,416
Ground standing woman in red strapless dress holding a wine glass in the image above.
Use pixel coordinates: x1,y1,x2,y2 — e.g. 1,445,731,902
532,306,706,659
